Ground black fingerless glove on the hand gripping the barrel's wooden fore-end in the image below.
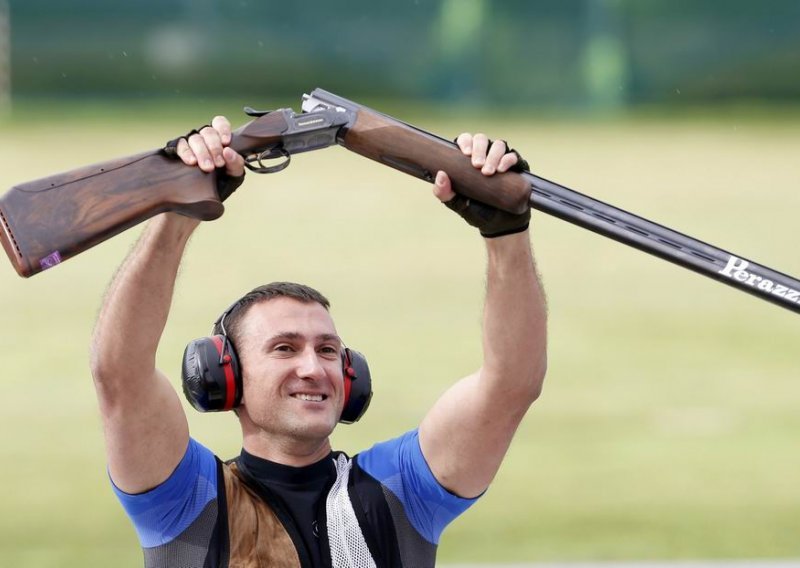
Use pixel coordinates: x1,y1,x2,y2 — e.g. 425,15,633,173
444,140,531,239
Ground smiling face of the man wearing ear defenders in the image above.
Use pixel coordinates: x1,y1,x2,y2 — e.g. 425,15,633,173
237,297,344,441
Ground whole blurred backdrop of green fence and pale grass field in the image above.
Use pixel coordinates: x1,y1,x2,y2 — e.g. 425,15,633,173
0,0,800,567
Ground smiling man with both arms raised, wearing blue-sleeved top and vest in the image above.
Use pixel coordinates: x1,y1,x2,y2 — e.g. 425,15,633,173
92,117,546,568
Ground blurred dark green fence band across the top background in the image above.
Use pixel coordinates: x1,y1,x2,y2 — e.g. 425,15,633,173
9,0,800,107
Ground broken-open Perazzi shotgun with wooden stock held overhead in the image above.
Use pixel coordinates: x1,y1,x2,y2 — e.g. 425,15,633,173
0,89,800,318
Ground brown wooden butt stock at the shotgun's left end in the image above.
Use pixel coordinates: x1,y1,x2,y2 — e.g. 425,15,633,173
0,150,224,277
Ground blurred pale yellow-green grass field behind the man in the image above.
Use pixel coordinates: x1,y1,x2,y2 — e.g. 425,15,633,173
0,100,800,568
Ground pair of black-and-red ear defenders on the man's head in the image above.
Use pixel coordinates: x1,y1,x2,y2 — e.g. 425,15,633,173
181,301,372,424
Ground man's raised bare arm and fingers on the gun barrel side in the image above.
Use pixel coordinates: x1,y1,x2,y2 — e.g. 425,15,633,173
419,135,547,497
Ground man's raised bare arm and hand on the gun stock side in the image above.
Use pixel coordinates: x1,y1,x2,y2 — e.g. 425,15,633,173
91,117,244,493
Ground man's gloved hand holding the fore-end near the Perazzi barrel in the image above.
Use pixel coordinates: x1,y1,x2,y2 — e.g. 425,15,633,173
433,133,531,238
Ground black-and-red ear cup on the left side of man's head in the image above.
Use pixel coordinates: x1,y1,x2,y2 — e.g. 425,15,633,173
181,335,242,412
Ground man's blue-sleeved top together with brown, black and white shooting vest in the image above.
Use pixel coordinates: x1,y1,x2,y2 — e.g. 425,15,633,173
129,431,466,568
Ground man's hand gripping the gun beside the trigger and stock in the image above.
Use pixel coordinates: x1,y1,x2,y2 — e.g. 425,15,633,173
164,116,244,201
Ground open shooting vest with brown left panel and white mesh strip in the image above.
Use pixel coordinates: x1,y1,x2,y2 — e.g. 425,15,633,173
144,452,436,568
